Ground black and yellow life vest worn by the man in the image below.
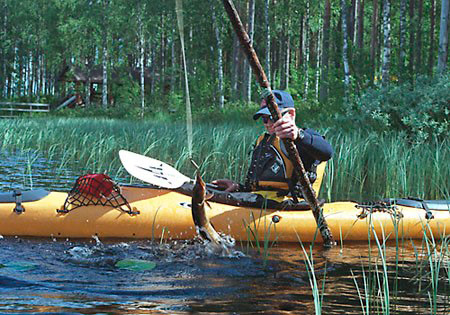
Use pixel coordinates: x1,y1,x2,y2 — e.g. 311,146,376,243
246,134,326,195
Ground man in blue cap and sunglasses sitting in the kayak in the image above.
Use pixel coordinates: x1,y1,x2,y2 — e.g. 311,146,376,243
212,90,333,199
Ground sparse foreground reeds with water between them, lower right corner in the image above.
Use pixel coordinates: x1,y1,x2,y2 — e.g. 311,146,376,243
299,225,450,315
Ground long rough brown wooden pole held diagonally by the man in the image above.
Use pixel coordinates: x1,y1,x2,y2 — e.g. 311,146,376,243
223,0,334,247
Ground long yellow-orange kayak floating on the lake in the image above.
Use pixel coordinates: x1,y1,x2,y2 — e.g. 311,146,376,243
0,186,450,242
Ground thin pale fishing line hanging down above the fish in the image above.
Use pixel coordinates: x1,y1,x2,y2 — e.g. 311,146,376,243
175,0,193,159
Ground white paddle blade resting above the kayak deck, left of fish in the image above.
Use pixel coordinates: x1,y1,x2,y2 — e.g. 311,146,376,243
119,150,191,188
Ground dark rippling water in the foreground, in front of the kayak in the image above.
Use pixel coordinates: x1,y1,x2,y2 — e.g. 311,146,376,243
0,238,450,314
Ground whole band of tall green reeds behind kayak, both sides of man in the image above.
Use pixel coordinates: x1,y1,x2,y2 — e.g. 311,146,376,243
0,117,450,201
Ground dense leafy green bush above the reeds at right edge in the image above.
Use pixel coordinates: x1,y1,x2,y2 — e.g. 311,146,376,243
338,75,450,142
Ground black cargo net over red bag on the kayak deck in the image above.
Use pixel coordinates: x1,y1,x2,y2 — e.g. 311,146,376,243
56,174,139,214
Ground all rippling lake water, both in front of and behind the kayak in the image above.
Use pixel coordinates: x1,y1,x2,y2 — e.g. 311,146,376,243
0,152,450,314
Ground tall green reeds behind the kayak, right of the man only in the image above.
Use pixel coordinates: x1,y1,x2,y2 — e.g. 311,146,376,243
322,132,450,200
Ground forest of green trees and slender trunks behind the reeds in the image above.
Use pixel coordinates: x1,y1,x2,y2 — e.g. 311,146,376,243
0,0,450,142
